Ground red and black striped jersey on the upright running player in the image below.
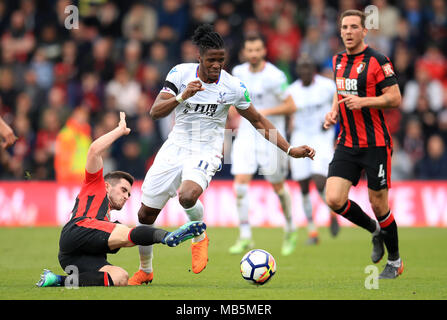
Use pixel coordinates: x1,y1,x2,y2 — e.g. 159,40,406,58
332,46,397,148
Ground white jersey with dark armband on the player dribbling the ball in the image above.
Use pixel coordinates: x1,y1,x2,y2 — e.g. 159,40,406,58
161,63,251,154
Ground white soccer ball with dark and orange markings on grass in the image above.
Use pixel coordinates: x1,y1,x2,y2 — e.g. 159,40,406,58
241,249,276,285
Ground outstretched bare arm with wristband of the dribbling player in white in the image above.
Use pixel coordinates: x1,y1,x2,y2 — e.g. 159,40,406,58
238,104,315,159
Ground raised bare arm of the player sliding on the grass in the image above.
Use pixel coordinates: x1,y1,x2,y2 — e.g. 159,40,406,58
85,112,130,173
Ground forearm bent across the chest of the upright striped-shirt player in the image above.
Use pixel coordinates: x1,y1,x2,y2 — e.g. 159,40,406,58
338,84,402,110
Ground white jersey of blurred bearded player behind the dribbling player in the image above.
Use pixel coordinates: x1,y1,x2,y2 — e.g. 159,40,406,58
232,62,287,135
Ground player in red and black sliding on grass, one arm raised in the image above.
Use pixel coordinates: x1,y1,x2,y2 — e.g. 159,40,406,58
37,112,206,287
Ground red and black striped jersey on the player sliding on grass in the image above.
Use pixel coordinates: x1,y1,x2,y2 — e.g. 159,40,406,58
71,168,110,221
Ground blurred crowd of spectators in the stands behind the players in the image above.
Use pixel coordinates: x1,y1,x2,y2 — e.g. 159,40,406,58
0,0,447,181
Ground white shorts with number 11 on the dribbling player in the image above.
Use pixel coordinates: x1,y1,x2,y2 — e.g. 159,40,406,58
141,140,222,209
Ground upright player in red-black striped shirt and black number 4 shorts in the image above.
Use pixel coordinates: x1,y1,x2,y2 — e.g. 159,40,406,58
324,10,404,279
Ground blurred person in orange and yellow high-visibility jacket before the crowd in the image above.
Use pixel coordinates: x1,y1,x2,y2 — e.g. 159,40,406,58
54,106,92,183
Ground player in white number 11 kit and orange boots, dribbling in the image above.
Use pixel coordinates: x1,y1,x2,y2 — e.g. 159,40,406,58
129,25,315,285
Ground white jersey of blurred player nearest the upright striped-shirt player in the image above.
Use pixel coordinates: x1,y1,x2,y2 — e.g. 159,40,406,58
286,74,336,135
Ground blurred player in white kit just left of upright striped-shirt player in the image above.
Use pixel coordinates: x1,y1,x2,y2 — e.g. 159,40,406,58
286,55,339,244
